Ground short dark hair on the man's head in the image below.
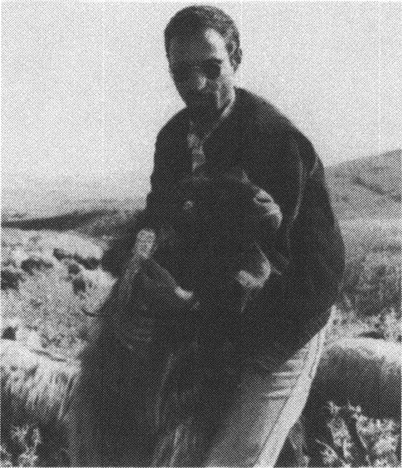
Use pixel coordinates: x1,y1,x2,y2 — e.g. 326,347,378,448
165,5,240,54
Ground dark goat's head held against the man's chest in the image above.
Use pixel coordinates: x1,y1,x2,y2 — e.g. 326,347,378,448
152,167,281,300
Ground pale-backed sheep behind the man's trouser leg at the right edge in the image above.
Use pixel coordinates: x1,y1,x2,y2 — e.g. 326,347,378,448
303,337,401,466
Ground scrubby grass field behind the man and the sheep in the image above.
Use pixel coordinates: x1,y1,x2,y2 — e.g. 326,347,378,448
2,214,401,466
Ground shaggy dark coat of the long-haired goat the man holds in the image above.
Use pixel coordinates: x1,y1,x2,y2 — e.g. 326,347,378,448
69,170,278,466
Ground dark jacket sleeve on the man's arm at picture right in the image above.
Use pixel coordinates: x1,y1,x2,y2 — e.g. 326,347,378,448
243,132,345,350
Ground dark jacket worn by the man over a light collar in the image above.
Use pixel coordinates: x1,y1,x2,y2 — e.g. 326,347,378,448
143,89,344,351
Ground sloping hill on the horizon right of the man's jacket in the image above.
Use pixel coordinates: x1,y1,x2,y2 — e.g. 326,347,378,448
325,150,402,219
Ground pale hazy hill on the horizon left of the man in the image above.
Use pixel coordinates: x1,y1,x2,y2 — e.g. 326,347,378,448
1,171,149,224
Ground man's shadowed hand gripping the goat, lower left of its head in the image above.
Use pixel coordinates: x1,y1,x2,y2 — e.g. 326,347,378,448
139,258,194,314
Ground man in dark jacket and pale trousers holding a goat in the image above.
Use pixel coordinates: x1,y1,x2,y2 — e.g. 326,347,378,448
112,6,344,466
